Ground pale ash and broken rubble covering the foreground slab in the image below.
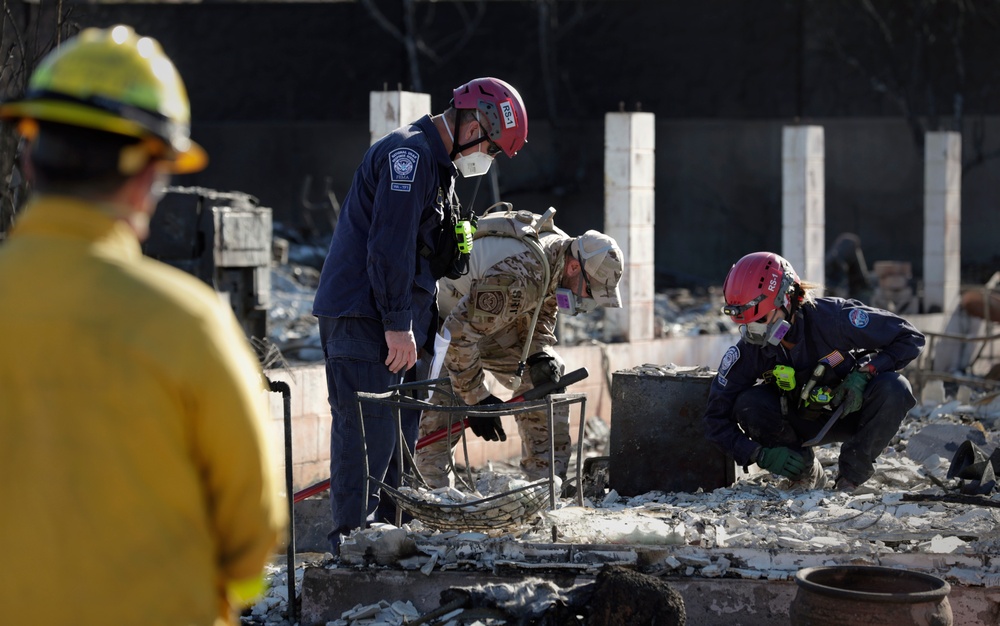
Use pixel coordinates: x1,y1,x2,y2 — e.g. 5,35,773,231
244,385,1000,626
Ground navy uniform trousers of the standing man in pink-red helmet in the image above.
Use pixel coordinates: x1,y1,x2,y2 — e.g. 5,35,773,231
319,317,420,552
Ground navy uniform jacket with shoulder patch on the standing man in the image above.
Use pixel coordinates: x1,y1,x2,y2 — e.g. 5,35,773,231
313,116,458,346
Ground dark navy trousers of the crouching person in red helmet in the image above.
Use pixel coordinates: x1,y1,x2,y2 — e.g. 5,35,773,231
733,372,916,485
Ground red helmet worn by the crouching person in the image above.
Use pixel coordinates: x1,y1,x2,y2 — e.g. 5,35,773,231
722,252,799,324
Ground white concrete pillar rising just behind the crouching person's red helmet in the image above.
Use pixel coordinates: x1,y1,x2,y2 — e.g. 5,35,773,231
781,126,826,286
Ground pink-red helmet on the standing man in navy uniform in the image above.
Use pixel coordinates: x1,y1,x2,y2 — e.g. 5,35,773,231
452,76,528,157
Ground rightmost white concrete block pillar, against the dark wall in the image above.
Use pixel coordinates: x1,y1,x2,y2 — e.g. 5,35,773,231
923,132,962,313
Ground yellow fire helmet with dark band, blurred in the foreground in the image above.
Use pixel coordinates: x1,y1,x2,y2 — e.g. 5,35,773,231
0,25,208,174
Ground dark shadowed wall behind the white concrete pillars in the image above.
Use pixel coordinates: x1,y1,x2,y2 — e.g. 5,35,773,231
48,0,1000,286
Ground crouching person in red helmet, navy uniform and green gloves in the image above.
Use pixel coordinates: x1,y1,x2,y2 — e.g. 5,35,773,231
704,252,924,491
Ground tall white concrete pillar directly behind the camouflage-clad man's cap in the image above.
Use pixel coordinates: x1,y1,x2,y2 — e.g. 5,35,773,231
603,113,656,341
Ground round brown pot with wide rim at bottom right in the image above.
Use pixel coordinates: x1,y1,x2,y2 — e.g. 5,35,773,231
789,565,952,626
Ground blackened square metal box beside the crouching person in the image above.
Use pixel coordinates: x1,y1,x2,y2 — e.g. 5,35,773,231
608,371,736,496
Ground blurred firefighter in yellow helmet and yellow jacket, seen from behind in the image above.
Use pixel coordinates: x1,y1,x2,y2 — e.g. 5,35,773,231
0,26,286,625
